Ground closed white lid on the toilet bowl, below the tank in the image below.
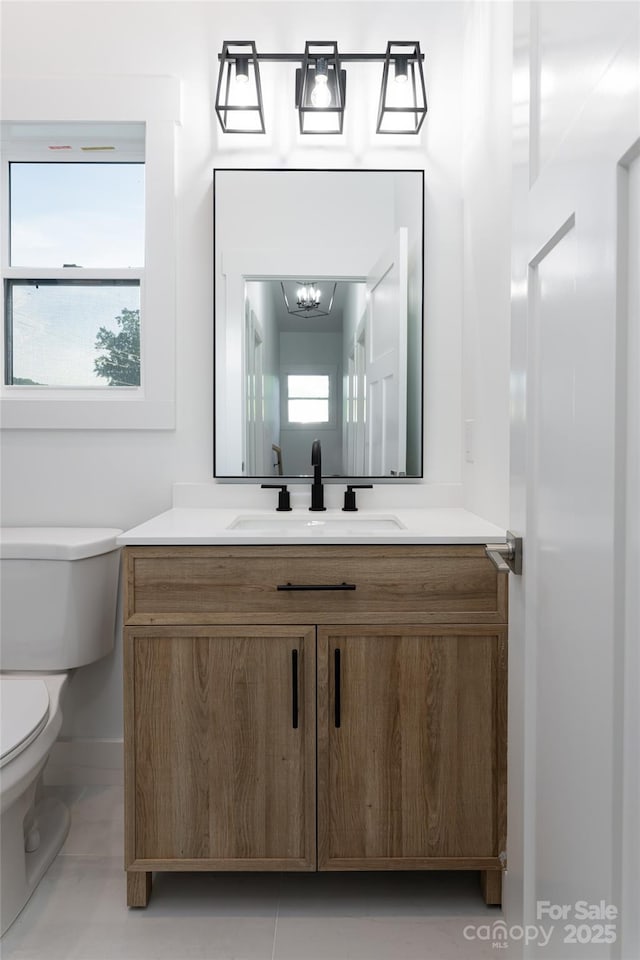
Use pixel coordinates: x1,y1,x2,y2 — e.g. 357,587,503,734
0,676,49,767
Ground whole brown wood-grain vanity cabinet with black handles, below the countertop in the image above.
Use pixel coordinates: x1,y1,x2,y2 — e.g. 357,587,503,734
124,545,507,906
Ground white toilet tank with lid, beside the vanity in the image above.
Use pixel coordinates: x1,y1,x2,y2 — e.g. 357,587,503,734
0,527,122,671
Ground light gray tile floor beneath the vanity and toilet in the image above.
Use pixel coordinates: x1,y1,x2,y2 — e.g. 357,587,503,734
0,786,507,960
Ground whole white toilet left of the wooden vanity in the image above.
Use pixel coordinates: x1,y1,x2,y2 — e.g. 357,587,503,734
0,527,121,934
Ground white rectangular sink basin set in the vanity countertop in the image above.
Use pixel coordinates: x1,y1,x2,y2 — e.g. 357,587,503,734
227,512,406,536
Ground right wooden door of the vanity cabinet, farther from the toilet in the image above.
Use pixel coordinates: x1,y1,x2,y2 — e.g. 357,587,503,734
318,625,506,871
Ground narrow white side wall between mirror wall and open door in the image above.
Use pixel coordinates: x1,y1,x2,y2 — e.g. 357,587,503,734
461,3,512,526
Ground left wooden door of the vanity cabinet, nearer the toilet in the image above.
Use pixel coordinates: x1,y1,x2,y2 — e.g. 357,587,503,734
125,626,316,886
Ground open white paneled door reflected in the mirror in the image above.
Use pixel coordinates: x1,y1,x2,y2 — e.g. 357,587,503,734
365,227,408,477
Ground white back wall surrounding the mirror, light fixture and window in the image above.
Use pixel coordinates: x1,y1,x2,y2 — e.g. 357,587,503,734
1,0,506,752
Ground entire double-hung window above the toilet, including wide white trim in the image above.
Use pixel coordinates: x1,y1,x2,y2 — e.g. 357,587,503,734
0,76,180,430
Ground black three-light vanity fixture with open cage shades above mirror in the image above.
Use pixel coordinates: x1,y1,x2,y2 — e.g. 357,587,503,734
215,40,427,134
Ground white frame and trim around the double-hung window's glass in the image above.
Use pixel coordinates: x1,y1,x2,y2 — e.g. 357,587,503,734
0,77,180,430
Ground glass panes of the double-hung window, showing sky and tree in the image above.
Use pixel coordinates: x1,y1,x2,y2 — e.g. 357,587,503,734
5,144,144,388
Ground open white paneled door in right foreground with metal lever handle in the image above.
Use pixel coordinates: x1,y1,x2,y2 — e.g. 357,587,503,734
505,2,640,960
